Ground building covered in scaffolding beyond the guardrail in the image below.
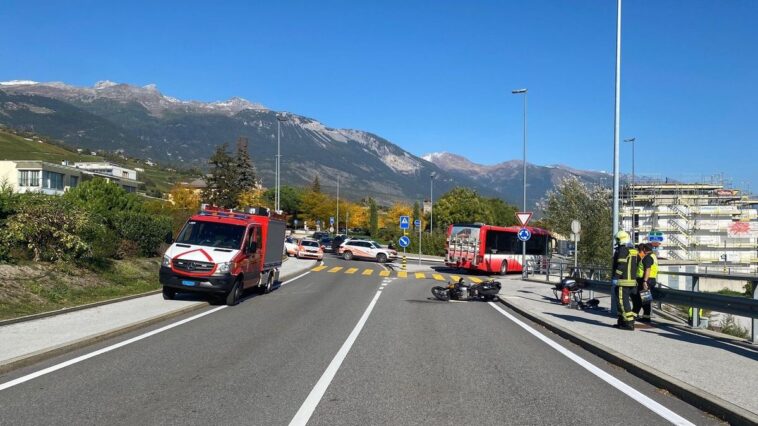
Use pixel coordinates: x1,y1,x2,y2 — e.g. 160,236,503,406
621,181,758,273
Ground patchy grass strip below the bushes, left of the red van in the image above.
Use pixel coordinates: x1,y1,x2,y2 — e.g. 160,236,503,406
0,258,160,319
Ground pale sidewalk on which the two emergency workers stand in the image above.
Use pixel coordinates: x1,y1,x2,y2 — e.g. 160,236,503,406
500,277,758,422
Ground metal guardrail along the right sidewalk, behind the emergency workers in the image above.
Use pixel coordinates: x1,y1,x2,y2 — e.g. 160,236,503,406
527,259,758,344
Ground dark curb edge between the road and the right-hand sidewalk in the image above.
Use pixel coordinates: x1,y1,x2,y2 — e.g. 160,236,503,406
499,297,758,425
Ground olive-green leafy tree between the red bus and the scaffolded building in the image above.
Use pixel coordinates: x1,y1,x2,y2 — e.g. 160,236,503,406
540,177,611,265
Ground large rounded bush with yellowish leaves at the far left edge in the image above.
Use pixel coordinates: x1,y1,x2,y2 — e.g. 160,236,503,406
3,194,91,261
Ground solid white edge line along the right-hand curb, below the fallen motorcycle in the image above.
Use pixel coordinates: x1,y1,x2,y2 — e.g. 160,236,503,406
489,302,694,426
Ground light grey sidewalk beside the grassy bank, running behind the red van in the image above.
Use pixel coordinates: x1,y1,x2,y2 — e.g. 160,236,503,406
0,258,315,374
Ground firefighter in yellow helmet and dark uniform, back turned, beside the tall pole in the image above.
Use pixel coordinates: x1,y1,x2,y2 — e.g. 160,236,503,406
613,231,638,330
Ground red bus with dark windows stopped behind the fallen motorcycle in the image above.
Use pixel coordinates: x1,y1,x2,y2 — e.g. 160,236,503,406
445,223,554,275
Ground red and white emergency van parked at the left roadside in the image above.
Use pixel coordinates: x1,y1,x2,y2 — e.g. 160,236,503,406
160,204,286,305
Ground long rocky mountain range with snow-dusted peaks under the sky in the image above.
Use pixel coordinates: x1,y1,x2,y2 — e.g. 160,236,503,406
0,81,609,208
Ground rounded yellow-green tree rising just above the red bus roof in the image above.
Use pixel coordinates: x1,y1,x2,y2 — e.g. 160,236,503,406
434,187,493,228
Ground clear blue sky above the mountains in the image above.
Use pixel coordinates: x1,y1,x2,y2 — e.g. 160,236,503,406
0,0,758,192
